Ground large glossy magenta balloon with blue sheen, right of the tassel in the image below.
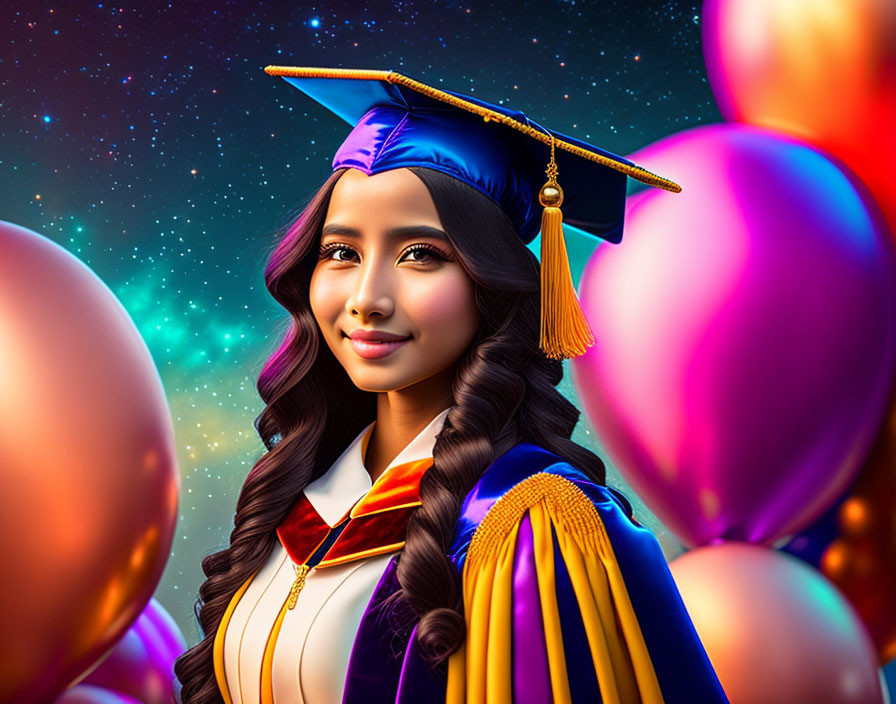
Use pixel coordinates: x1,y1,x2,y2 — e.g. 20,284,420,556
573,124,896,545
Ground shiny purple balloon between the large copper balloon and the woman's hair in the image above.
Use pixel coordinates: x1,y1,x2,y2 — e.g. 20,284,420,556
84,598,185,704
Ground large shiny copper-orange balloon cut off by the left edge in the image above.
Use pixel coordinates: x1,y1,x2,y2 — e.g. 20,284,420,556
0,221,179,702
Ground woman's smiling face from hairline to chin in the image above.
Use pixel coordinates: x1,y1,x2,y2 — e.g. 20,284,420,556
310,169,480,392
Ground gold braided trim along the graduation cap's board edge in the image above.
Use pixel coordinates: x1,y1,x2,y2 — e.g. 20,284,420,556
264,66,681,193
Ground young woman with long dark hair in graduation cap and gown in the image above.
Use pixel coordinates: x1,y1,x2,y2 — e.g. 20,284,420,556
175,69,727,704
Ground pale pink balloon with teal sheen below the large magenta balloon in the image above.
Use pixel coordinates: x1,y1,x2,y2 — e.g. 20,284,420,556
669,543,885,704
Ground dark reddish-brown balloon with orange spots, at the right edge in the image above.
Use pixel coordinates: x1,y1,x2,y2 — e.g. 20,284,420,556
818,376,896,664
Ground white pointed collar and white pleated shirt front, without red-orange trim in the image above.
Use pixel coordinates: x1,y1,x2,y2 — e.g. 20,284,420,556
224,409,449,704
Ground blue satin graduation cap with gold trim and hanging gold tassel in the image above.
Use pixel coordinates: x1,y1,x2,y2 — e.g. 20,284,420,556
265,66,681,359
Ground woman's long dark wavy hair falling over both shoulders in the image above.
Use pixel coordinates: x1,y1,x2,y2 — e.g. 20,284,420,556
174,167,605,704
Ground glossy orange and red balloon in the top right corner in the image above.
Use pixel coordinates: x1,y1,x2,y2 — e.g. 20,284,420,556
703,0,896,233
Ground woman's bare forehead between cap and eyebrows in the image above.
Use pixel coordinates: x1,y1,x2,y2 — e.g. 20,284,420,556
325,169,441,227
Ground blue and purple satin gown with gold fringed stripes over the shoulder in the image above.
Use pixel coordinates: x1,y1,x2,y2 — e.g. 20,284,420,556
216,426,728,704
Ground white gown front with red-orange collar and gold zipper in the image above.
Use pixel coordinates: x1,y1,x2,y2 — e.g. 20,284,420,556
213,410,448,704
